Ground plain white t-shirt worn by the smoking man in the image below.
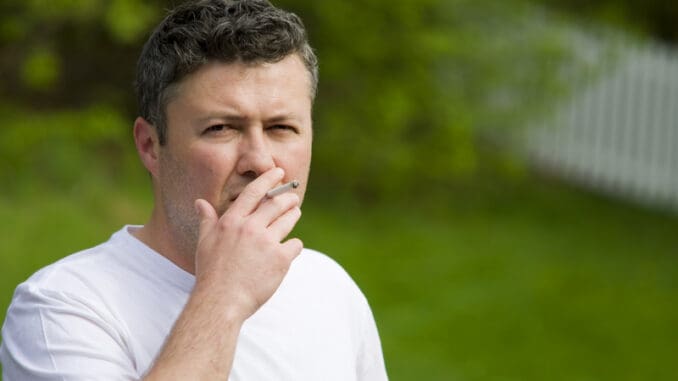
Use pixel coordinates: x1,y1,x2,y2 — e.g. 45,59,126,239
0,226,387,381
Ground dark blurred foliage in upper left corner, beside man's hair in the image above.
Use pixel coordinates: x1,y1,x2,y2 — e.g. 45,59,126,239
0,0,162,113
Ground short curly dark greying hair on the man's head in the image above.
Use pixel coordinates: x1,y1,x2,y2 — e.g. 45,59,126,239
135,0,318,145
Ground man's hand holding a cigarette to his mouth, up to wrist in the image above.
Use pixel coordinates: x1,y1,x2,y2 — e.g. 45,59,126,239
195,168,303,320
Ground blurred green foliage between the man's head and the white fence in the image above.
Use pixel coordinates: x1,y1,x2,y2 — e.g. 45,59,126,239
280,0,571,196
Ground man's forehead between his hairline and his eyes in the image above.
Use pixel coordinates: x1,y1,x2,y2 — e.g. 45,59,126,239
165,57,312,123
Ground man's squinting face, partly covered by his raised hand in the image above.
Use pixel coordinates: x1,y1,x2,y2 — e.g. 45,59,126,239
156,55,312,245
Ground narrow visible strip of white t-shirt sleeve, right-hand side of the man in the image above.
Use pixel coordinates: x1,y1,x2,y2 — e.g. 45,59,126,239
357,300,388,381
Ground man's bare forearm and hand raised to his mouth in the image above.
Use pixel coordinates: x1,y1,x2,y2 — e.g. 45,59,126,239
145,168,303,380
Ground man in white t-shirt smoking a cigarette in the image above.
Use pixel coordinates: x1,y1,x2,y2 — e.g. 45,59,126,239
0,0,386,381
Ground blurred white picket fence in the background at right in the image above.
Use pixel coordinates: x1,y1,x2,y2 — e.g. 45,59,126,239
526,35,678,212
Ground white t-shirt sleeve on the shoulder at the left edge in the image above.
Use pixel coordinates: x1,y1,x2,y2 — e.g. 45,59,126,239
0,284,139,381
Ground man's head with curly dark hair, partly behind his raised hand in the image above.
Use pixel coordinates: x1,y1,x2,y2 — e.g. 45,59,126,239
134,0,317,268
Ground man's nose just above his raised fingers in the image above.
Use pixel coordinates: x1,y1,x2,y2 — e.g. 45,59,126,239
236,132,275,179
